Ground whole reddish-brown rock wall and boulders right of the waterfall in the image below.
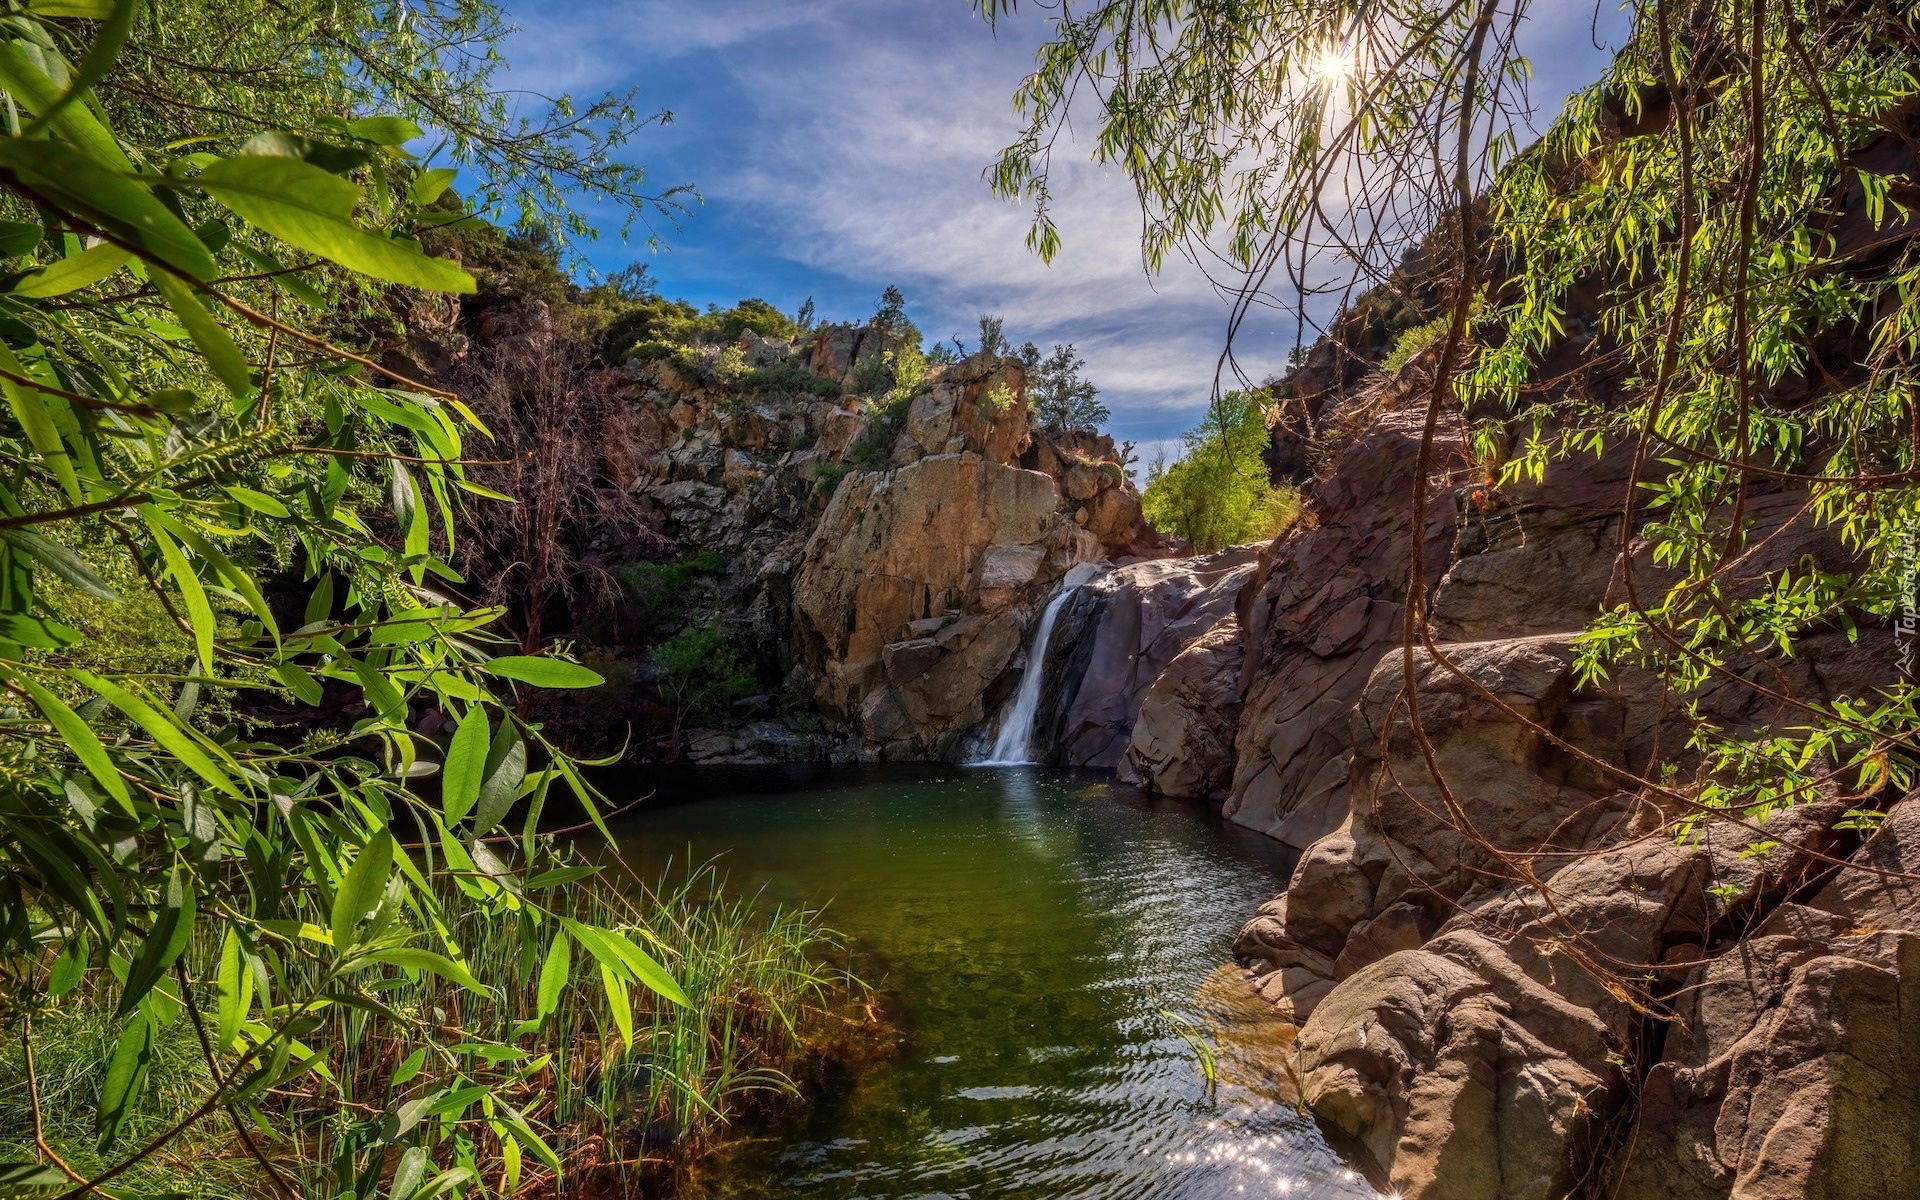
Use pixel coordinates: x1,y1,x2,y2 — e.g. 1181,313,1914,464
1205,366,1920,1200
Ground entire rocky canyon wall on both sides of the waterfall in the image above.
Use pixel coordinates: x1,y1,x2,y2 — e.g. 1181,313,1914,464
424,288,1920,1200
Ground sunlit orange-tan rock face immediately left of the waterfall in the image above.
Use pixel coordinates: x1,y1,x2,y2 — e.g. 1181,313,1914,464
756,348,1154,760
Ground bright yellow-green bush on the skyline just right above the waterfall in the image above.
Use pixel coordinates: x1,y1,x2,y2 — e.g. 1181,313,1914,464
1140,392,1298,553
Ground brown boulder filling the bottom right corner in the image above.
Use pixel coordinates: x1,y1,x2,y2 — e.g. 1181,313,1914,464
1615,797,1920,1200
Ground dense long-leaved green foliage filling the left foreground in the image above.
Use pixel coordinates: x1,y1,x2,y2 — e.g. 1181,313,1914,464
0,0,682,1196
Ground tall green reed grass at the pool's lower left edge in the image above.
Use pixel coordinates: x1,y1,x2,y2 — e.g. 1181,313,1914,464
0,864,856,1200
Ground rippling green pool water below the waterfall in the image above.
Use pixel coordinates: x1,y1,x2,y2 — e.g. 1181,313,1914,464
620,768,1375,1200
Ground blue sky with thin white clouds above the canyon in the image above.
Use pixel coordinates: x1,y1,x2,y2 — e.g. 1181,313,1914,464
503,0,1622,457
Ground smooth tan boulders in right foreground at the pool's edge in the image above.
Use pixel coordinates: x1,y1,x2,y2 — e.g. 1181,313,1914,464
1236,614,1896,1200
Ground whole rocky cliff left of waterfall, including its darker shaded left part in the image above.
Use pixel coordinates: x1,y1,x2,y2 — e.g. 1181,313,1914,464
634,326,1160,760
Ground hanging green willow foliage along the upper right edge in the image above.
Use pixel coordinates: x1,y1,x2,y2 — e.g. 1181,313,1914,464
1467,0,1920,829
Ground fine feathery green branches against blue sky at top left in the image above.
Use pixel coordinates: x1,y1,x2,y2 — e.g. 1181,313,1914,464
107,0,691,253
